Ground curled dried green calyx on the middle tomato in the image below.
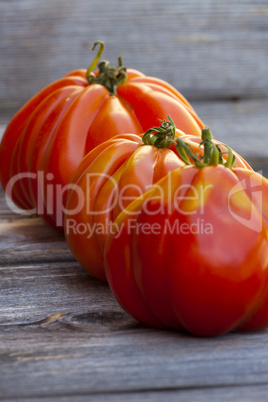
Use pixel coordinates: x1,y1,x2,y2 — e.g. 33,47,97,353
142,116,176,149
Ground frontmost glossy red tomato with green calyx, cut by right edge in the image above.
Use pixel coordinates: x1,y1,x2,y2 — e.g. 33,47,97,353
104,130,268,336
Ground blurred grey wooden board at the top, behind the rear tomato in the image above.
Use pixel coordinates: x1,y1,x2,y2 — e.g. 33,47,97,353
0,0,268,113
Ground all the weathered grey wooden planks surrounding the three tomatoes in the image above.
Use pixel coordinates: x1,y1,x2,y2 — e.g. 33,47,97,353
0,0,268,402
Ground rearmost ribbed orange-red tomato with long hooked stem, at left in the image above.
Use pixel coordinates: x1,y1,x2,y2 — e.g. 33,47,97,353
0,42,203,228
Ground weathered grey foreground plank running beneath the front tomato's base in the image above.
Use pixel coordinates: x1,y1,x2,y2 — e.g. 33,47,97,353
0,300,268,398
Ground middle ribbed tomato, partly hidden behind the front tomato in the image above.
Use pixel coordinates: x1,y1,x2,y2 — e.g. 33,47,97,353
65,118,250,281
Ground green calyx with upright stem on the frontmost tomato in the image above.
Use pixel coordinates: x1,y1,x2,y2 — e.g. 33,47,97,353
176,127,236,169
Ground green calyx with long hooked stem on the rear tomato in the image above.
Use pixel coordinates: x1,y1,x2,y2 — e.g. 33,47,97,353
86,41,127,95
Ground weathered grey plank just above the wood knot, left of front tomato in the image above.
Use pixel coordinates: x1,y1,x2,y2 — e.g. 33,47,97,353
0,257,119,329
